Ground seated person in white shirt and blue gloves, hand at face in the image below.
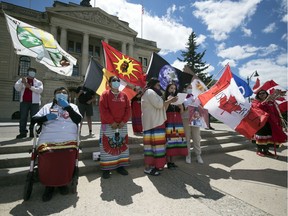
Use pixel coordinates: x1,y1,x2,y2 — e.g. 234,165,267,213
32,87,82,202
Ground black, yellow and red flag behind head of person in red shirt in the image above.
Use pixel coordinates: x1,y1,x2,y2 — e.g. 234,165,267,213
83,58,137,100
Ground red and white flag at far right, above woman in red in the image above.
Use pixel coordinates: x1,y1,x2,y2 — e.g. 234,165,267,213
254,80,288,113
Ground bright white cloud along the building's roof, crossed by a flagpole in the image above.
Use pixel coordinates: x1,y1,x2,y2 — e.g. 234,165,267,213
96,0,192,55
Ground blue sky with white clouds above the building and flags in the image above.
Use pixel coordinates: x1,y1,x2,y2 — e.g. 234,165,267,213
2,0,288,88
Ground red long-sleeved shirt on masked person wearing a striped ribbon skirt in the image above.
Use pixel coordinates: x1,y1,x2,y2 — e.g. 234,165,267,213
99,90,131,124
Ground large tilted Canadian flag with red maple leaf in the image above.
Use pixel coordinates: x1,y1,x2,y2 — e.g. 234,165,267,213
198,65,269,139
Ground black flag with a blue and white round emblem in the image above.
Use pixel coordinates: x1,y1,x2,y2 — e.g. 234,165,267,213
147,52,192,90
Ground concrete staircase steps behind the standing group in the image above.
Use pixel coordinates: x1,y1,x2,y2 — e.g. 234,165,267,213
0,124,253,186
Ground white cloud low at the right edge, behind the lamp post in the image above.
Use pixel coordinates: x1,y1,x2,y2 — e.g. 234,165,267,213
239,58,287,88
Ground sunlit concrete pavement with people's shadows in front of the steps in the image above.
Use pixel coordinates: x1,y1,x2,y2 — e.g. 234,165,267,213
0,122,287,216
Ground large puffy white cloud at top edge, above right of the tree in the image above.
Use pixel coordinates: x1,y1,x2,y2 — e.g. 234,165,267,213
192,0,261,41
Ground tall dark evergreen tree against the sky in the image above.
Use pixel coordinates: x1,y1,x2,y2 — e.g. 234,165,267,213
178,31,212,85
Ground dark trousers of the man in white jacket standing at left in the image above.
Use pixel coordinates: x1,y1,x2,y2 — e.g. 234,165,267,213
19,102,40,134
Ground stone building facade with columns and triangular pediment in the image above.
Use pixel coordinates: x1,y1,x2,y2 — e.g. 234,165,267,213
0,1,159,120
